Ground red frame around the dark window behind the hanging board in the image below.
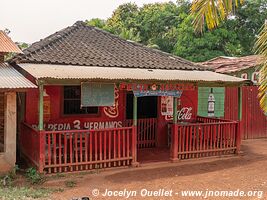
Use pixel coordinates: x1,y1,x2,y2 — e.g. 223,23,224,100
60,85,101,118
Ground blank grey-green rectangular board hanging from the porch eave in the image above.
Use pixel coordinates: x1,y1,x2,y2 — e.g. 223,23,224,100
81,82,115,107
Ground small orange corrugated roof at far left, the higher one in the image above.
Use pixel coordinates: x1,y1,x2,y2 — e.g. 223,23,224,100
0,30,22,53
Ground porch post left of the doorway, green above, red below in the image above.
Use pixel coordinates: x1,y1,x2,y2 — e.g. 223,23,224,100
132,96,139,167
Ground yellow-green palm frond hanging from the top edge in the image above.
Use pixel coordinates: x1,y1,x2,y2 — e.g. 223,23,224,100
191,0,244,32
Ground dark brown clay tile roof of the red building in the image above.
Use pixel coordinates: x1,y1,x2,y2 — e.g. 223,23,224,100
13,22,207,70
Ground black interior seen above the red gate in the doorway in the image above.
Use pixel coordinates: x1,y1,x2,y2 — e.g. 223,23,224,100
126,93,158,119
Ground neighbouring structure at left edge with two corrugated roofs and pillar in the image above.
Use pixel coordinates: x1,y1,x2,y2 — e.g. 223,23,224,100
0,31,36,173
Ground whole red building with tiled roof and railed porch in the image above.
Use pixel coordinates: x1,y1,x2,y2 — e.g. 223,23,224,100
12,22,247,173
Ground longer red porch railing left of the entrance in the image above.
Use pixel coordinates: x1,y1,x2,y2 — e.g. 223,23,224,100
22,124,136,173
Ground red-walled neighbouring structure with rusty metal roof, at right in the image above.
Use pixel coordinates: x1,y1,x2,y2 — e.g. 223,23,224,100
202,55,267,139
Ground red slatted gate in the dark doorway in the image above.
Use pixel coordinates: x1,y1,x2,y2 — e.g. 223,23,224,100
125,118,157,149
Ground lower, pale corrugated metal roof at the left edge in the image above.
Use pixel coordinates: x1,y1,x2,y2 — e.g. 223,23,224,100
0,63,37,89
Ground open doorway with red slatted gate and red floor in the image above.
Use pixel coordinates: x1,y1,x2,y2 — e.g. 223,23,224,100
126,93,170,163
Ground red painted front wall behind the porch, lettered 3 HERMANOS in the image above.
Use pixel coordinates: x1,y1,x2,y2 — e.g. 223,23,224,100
25,86,198,146
